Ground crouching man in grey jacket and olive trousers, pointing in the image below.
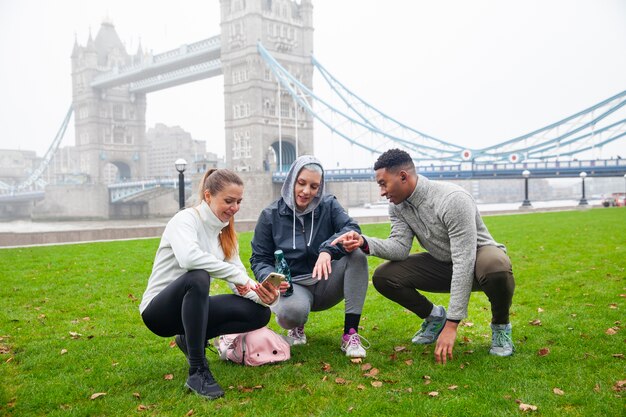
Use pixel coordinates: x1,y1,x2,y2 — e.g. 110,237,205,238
332,149,515,364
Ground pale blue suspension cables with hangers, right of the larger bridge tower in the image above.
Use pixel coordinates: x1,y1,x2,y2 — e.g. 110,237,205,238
258,42,626,164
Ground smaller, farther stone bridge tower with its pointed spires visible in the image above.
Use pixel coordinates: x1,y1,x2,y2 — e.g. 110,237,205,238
72,21,147,184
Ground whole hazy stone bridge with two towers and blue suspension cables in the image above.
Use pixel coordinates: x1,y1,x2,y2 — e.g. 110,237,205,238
0,0,626,218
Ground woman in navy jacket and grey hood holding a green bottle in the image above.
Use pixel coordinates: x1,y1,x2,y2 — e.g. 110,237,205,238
250,155,369,358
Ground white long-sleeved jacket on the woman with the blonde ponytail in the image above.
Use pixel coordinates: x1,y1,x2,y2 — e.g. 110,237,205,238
139,201,272,313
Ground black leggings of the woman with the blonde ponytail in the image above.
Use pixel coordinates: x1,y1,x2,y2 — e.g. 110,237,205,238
141,270,271,368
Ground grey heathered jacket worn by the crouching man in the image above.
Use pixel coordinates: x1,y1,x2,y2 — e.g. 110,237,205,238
365,175,506,320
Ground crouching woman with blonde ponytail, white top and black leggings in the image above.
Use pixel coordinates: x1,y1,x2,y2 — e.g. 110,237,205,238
139,169,278,399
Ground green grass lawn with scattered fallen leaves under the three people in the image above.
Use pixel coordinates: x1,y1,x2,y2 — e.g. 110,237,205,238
0,208,626,417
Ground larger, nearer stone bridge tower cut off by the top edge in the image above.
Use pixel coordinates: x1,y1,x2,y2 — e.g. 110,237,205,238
220,0,313,174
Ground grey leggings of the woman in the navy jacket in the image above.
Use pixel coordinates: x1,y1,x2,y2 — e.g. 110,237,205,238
272,250,369,329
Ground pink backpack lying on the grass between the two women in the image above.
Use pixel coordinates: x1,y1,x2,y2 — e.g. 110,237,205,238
217,327,291,366
